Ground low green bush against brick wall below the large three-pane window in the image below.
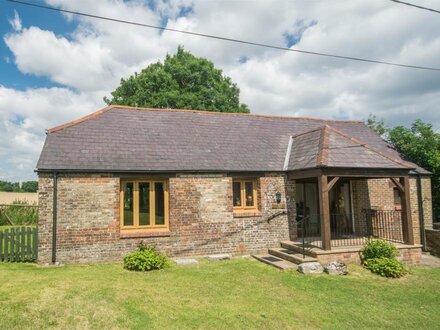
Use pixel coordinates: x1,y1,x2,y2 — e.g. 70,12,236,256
124,245,169,272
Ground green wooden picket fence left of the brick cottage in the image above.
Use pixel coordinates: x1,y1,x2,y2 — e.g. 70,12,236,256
0,226,38,262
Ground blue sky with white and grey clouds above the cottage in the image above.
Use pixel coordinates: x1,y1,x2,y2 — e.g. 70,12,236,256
0,0,440,181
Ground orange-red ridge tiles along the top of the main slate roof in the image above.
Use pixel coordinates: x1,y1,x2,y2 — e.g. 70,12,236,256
47,104,362,133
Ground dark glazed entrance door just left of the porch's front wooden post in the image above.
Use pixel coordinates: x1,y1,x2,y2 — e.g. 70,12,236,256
296,182,321,236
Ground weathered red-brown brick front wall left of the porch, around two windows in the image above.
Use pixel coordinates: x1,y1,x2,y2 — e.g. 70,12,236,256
39,174,294,263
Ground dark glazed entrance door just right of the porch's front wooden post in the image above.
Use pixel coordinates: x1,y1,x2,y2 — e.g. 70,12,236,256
329,181,354,235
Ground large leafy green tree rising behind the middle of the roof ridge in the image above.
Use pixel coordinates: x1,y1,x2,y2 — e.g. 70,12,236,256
104,47,249,113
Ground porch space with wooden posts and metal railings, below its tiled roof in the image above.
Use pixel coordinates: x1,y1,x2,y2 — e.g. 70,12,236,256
289,168,414,251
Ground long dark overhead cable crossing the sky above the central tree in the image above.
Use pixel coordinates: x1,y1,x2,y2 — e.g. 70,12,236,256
4,0,440,71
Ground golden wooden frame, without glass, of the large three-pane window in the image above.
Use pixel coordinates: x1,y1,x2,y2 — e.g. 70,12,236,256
119,179,169,231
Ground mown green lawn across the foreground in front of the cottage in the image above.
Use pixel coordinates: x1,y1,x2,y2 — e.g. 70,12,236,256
0,260,440,329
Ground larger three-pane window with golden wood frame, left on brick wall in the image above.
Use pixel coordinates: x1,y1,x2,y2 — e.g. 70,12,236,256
121,180,168,230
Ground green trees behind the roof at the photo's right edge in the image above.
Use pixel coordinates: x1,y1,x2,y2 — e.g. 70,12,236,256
366,115,440,217
